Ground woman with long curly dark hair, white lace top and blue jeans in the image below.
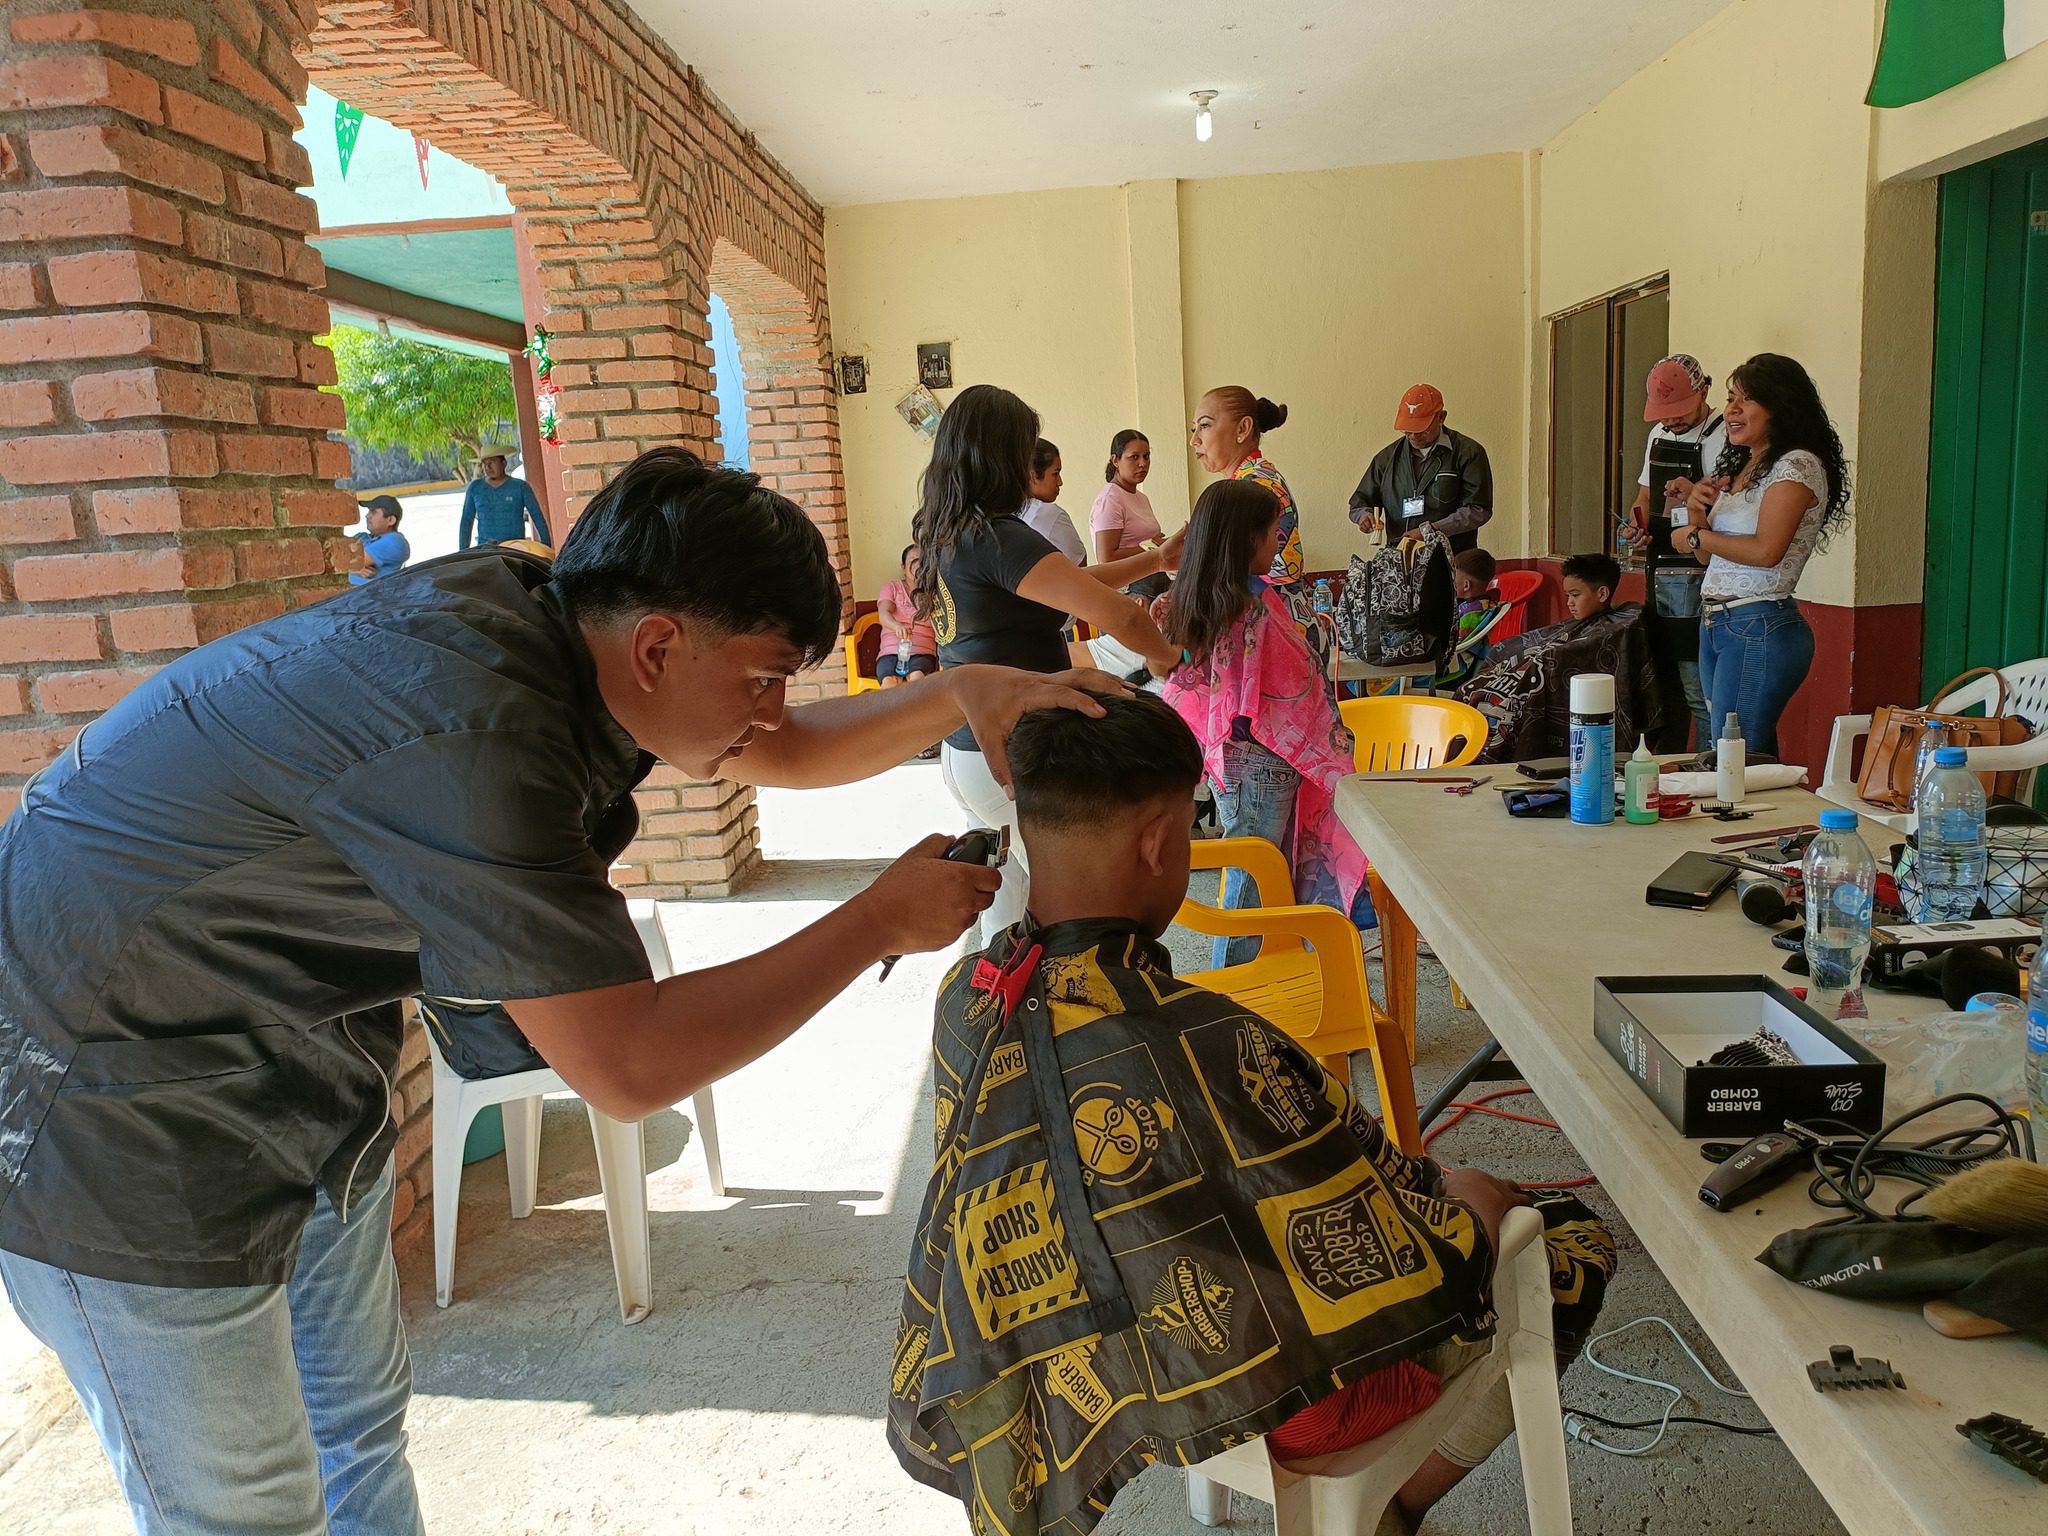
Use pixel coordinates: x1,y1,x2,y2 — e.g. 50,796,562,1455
1671,352,1849,754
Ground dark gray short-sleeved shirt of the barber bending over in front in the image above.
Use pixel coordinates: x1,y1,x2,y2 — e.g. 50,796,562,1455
0,549,653,1286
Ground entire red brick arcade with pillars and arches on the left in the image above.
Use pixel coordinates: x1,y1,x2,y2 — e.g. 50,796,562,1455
0,0,846,1247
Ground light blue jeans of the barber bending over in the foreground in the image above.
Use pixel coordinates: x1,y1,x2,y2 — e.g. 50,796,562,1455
0,1165,426,1536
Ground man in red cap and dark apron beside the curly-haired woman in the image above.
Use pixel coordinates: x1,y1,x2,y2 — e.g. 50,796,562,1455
1622,352,1726,752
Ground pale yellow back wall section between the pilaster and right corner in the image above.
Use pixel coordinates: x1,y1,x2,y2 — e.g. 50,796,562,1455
1180,156,1524,569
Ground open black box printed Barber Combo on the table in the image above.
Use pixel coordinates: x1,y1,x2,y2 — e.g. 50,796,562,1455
1593,977,1884,1139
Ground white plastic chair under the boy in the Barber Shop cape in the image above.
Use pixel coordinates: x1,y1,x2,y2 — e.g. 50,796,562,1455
1188,1206,1571,1536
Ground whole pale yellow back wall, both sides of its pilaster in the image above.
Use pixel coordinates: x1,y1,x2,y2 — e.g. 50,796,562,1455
825,156,1526,598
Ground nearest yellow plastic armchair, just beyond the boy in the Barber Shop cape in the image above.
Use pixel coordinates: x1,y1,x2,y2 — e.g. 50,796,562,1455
1174,838,1421,1157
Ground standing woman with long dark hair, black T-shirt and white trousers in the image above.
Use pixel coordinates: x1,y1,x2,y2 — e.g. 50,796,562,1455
913,385,1180,940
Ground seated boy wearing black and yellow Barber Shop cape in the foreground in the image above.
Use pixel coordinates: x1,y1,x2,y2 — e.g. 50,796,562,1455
889,696,1614,1536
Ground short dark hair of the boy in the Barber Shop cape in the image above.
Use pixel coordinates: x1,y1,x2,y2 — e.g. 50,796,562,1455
1010,694,1202,827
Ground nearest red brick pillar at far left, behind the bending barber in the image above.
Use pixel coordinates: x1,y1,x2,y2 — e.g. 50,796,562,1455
0,4,354,813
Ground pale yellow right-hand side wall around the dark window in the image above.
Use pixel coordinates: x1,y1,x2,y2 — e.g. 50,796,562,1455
1530,0,1874,604
